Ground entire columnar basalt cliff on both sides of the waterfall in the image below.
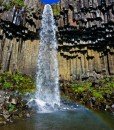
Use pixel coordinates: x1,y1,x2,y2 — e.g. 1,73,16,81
0,0,114,80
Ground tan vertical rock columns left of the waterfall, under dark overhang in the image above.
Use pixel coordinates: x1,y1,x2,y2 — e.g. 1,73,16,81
0,36,39,75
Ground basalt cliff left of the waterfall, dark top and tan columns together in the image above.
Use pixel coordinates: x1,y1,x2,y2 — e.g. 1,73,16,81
0,1,41,74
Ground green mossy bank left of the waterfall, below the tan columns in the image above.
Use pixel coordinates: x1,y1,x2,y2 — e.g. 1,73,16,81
0,72,35,93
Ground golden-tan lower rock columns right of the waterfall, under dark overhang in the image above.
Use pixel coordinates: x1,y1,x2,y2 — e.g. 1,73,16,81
59,44,114,80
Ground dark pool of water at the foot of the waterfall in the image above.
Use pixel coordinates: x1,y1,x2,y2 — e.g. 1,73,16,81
0,109,114,130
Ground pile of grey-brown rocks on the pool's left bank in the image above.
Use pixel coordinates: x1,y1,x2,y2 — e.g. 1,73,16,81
0,91,31,126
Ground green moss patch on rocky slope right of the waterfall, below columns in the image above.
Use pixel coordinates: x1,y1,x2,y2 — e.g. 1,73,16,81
71,77,114,102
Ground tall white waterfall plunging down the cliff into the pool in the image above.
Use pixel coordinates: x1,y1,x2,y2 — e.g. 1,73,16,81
35,4,60,111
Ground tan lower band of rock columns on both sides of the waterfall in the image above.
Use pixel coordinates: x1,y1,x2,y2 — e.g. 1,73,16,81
0,36,114,80
